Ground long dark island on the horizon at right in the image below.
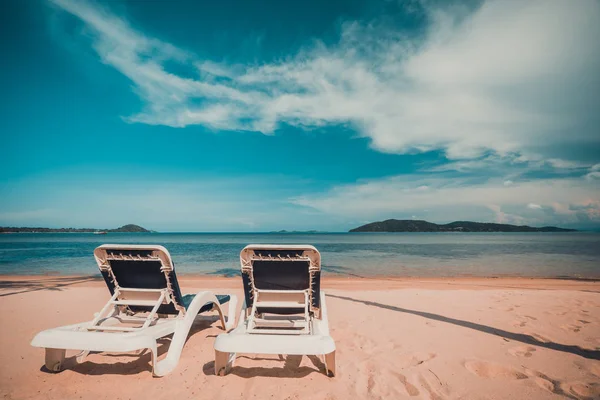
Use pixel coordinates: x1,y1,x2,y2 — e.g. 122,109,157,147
350,219,577,232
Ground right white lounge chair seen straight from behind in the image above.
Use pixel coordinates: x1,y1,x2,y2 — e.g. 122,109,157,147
215,245,335,376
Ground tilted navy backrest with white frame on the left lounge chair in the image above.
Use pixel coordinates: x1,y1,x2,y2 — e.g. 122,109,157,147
94,245,184,314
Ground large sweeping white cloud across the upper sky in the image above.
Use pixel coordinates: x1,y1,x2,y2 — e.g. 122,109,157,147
52,0,600,162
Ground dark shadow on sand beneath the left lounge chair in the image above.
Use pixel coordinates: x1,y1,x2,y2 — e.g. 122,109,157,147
40,315,225,375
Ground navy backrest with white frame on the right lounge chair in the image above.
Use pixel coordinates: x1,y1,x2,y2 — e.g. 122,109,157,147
240,245,321,313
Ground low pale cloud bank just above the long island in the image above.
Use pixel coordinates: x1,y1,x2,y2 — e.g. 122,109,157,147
292,174,600,224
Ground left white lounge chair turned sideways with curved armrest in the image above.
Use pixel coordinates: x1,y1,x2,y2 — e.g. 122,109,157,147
31,244,237,376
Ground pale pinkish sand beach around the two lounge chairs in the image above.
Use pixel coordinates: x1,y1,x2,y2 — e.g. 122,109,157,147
0,276,600,400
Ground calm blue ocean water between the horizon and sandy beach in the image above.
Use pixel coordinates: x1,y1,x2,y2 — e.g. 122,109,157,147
0,232,600,278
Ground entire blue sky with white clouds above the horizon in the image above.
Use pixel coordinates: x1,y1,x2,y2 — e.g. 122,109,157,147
0,0,600,231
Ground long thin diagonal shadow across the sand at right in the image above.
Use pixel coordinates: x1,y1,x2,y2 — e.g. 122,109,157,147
327,294,600,360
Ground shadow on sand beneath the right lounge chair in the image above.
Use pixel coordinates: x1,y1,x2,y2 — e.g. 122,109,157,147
202,354,325,378
